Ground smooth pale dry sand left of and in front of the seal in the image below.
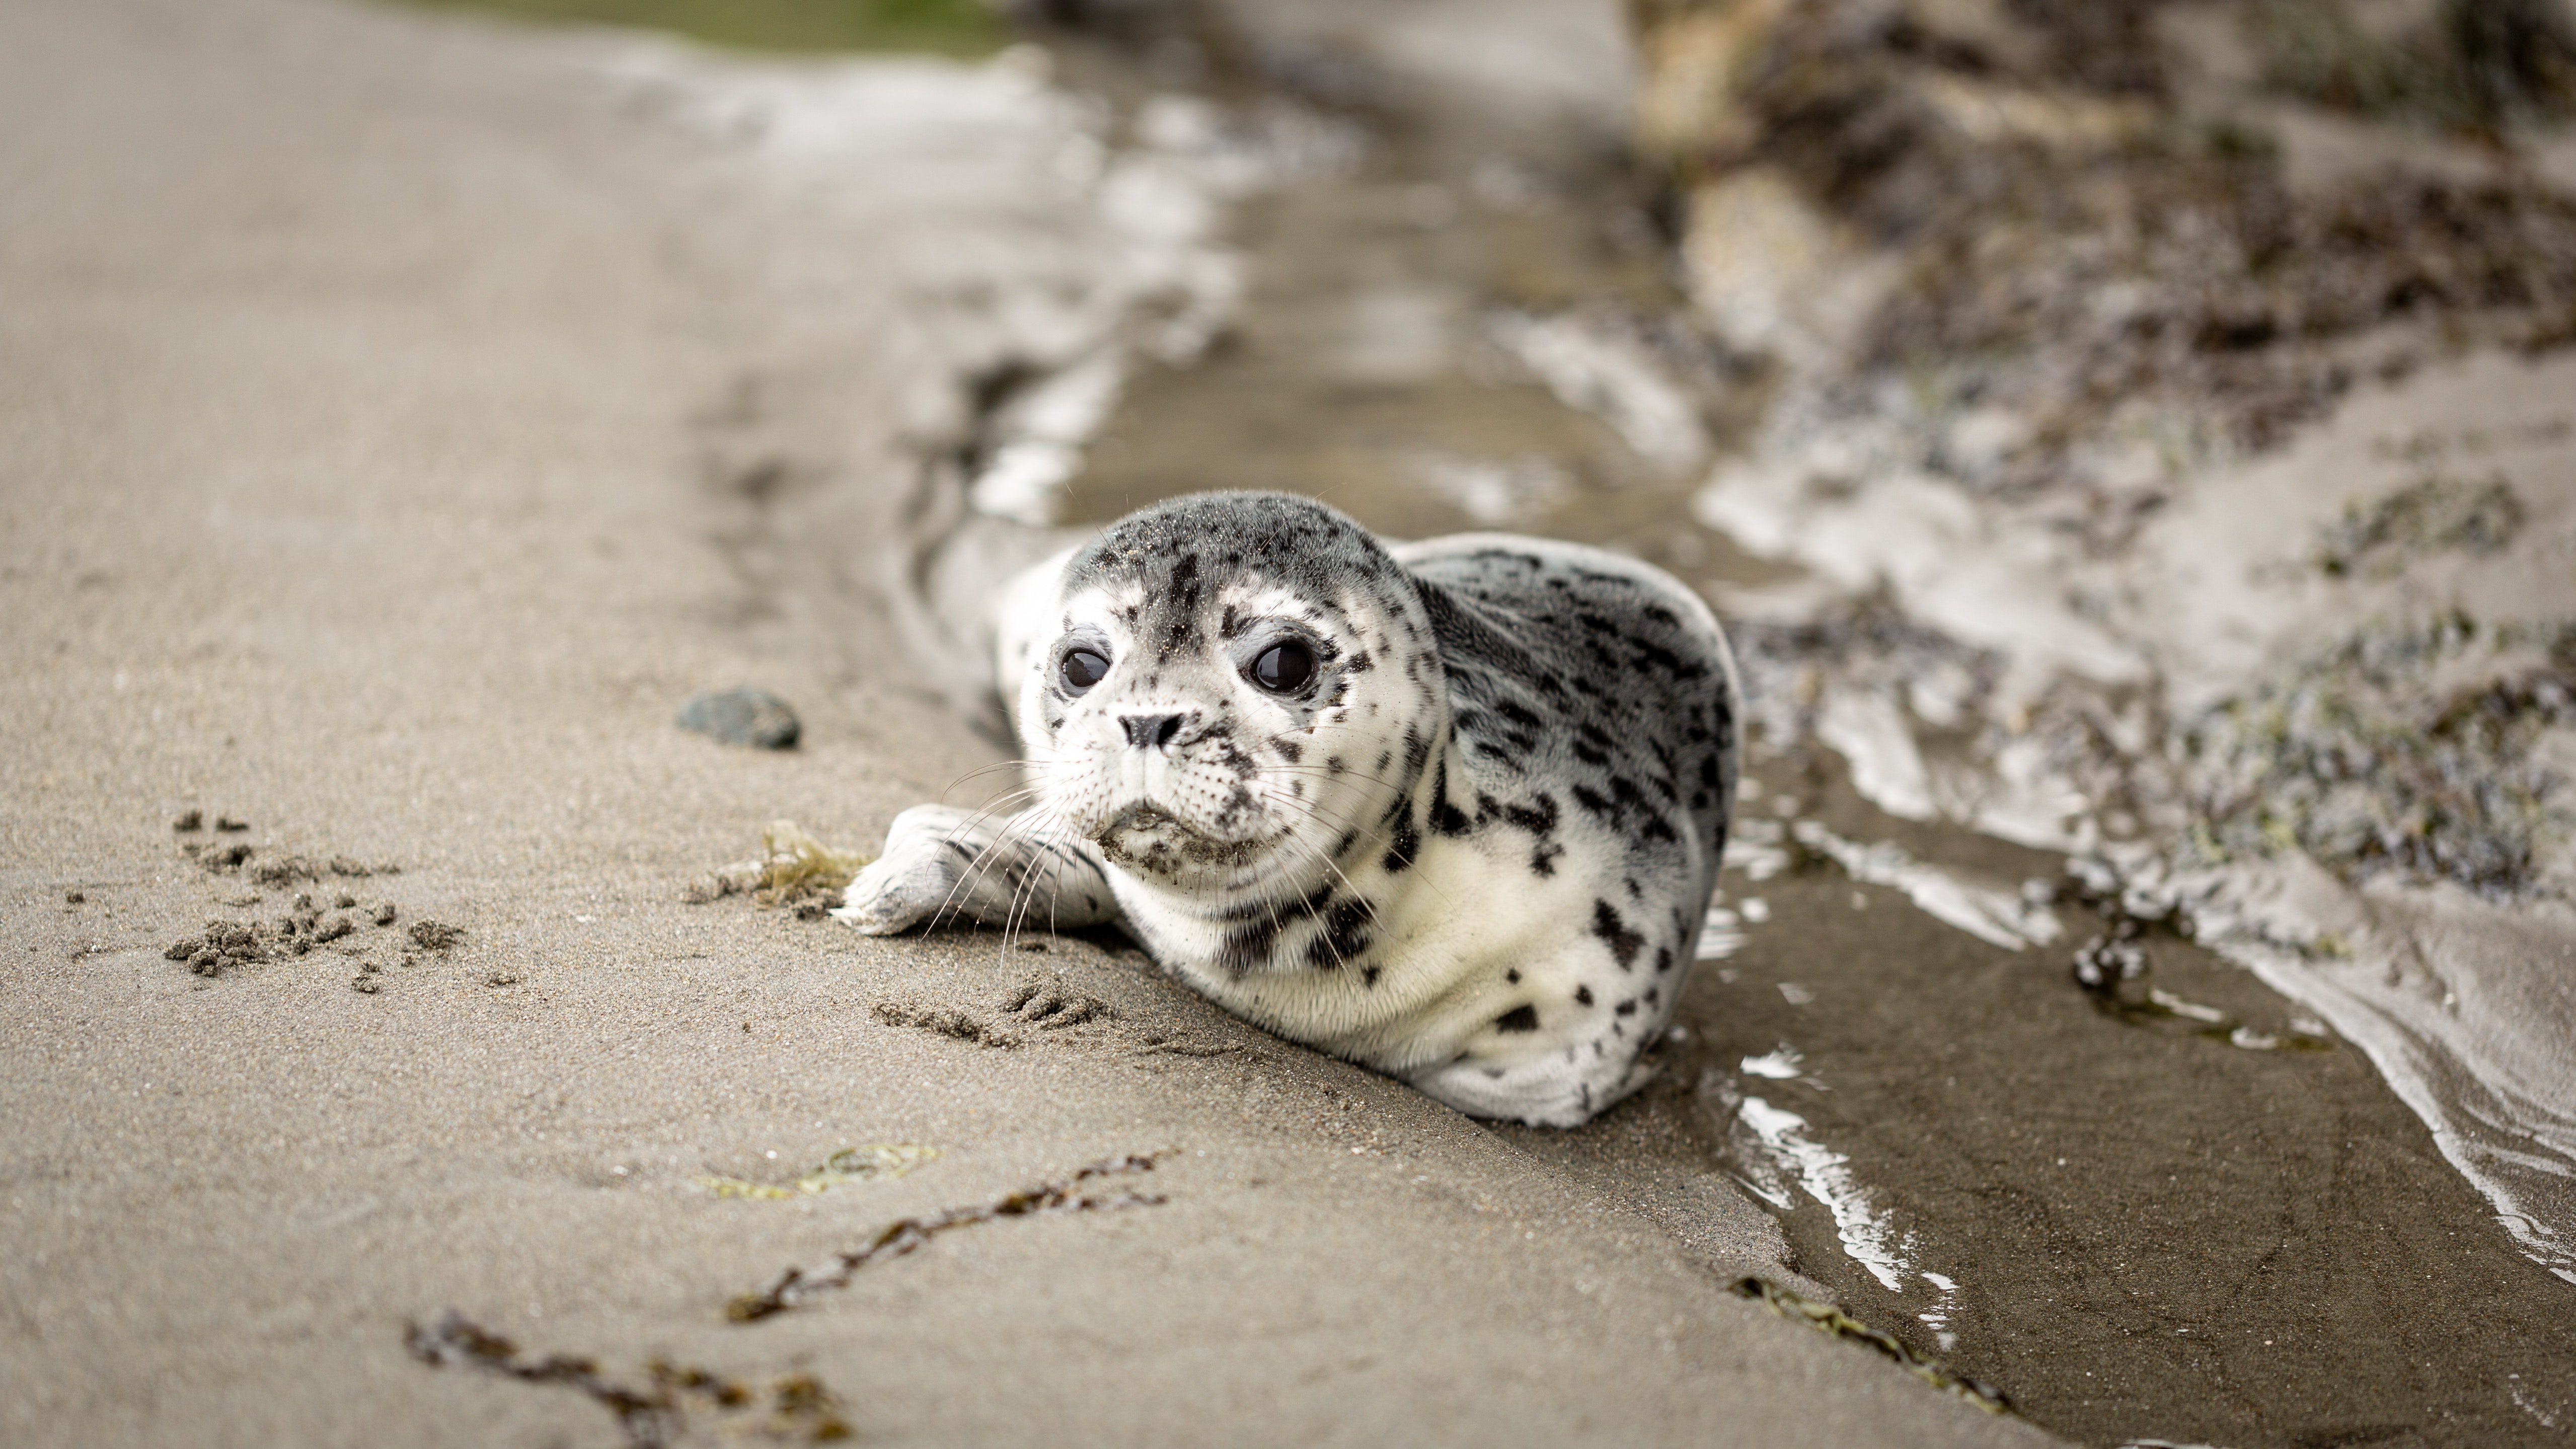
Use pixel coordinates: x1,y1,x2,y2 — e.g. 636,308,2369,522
0,0,2043,1444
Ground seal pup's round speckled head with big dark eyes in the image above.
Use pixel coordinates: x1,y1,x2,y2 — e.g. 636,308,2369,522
1018,494,1448,913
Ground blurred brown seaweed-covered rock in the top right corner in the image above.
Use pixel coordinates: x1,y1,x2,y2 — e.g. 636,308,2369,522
1638,0,2576,522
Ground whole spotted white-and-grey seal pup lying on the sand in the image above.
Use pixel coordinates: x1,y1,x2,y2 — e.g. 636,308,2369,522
835,492,1736,1127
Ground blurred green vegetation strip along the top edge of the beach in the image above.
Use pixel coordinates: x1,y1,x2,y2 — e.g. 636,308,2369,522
386,0,1010,57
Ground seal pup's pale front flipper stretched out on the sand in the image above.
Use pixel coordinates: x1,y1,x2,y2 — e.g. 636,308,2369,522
832,806,1118,937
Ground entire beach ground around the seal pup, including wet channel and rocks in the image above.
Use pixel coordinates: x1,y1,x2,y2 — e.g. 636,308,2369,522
20,0,2576,1449
